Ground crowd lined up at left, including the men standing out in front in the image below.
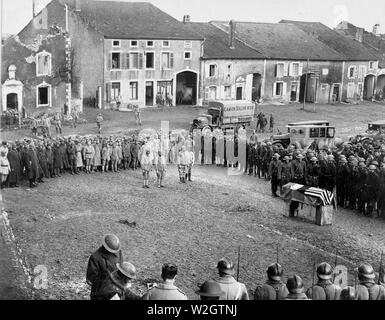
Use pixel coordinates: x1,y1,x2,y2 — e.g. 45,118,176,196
0,131,195,188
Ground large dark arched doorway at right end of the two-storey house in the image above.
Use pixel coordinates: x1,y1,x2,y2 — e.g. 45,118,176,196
175,71,198,105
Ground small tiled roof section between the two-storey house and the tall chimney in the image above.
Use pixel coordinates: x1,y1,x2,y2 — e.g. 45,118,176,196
186,22,264,59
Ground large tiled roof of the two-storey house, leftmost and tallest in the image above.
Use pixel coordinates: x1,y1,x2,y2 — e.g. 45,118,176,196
59,0,202,40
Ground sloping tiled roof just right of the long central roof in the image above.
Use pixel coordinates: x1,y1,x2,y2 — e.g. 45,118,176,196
280,20,377,61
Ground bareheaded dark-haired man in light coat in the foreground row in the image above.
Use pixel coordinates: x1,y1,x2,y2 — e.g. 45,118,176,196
143,264,187,300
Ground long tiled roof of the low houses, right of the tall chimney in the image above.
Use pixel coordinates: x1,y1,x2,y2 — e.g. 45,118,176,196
211,21,343,60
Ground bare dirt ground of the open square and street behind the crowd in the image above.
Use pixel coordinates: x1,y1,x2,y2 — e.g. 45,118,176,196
0,104,385,299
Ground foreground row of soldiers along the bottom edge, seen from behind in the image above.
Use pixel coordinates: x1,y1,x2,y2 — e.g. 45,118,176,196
86,234,385,300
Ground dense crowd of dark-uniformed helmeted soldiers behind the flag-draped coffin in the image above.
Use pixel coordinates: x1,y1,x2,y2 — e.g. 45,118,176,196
247,132,385,216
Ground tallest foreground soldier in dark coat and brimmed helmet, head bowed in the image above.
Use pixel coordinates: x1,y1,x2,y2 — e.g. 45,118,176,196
86,234,123,300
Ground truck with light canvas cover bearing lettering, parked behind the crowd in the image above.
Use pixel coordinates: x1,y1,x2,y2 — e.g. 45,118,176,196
191,100,255,131
